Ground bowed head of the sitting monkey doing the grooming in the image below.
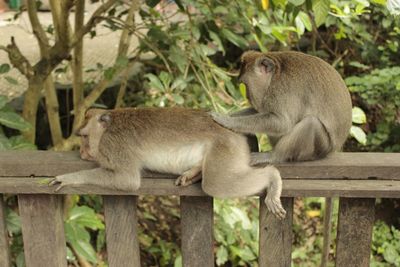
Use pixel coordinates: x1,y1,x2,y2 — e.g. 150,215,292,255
239,51,276,108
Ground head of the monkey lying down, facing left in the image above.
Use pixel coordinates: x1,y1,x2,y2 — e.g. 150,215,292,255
76,109,111,161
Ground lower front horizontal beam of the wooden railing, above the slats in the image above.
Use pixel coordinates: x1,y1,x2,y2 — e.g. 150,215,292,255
0,177,400,198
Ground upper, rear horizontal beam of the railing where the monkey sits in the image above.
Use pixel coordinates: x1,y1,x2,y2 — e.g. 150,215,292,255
0,151,400,180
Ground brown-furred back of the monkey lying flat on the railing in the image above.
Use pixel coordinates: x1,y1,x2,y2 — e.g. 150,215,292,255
106,108,237,147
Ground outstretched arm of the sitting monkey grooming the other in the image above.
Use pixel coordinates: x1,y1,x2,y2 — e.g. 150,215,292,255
211,112,290,135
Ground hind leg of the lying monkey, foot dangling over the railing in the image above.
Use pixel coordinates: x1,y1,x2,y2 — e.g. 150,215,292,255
202,138,286,219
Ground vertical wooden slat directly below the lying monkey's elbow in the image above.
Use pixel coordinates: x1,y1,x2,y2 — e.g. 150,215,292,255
103,196,140,267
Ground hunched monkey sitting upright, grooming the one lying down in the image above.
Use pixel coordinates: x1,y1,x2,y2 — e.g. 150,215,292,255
210,51,352,164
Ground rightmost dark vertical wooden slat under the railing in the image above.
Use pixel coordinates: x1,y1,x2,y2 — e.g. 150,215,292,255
336,198,375,267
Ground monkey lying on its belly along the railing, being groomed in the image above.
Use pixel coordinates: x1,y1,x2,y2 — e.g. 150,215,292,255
49,108,286,219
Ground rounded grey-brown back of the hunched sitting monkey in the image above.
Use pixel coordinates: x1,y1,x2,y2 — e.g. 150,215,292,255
266,52,352,149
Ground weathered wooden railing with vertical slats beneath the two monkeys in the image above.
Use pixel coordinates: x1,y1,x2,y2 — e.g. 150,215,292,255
0,151,400,267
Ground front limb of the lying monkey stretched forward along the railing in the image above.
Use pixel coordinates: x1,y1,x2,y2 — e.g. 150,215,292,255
49,168,140,191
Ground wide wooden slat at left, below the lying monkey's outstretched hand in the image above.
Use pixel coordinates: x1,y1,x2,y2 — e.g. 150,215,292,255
18,195,67,267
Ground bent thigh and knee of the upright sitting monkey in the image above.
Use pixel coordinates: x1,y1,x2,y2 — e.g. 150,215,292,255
271,116,333,162
